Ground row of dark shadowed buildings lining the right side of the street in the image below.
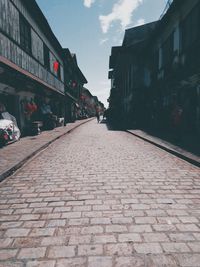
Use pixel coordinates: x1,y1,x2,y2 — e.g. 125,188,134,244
109,0,200,135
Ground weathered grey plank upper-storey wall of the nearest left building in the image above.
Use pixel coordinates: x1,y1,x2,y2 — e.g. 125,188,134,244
0,0,64,92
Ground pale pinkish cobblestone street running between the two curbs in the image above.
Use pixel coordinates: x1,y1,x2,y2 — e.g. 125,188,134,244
0,120,200,267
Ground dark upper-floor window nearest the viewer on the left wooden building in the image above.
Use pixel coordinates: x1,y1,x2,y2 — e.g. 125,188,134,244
20,15,31,54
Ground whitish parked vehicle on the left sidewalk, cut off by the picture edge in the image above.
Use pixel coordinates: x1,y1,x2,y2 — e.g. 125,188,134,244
0,112,21,147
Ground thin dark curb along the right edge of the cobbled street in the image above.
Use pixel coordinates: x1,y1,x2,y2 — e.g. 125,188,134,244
125,130,200,167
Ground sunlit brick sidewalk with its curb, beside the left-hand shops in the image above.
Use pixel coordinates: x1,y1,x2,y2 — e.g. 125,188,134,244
0,118,93,181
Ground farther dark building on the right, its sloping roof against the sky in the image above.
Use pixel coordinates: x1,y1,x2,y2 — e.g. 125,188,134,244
109,22,156,127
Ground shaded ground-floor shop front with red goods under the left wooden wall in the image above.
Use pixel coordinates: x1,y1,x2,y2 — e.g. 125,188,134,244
0,60,65,135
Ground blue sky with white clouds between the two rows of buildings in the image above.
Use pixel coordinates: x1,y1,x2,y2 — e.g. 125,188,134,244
36,0,167,107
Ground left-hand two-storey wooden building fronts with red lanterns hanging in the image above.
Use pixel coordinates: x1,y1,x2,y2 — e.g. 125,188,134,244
0,0,87,134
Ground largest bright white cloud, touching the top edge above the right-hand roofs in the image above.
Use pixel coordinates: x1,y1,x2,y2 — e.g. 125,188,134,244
99,0,143,33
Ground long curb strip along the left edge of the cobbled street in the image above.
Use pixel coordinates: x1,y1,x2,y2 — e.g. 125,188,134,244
0,118,94,182
